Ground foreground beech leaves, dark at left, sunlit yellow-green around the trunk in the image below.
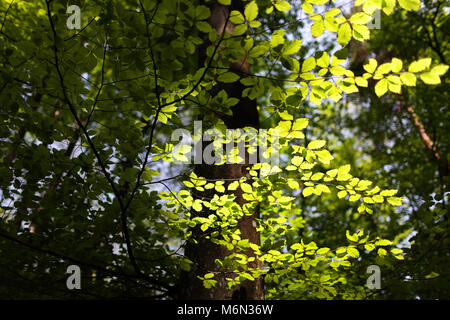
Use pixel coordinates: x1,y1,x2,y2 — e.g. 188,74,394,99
0,0,448,299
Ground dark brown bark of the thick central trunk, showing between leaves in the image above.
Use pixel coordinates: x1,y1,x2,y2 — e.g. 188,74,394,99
178,1,264,300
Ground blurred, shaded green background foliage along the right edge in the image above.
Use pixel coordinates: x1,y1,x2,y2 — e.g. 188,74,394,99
342,1,450,299
